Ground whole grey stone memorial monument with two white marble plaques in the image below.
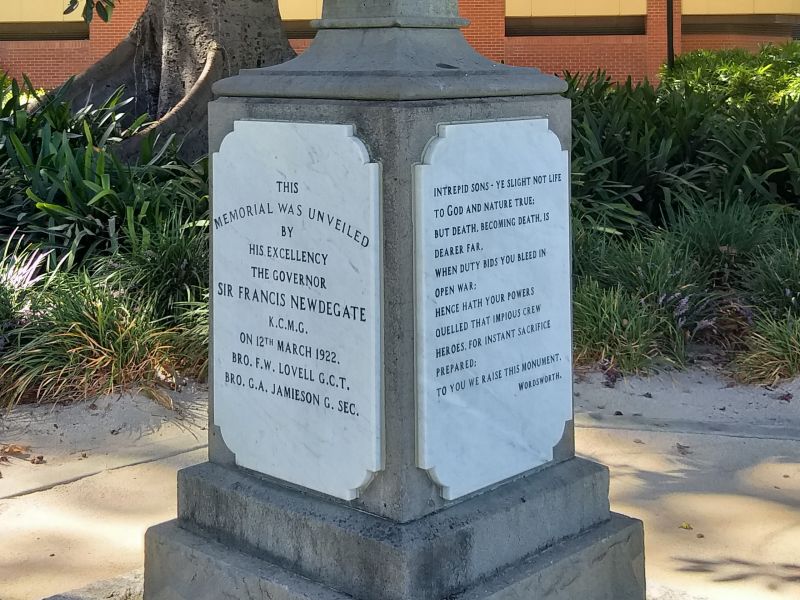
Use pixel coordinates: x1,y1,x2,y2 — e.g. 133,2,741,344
145,0,644,600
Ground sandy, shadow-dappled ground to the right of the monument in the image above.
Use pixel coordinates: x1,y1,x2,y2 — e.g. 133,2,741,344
575,369,800,600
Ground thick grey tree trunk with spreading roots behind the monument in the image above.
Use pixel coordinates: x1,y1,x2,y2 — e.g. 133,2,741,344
70,0,294,158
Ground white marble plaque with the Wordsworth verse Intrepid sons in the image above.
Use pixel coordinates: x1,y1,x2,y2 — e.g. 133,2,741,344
415,119,572,500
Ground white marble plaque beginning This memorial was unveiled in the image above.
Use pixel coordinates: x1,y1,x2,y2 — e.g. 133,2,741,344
212,121,382,500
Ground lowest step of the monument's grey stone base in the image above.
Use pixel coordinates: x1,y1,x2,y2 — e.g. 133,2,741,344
145,514,645,600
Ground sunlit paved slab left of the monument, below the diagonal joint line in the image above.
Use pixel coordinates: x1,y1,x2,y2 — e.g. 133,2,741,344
0,450,205,600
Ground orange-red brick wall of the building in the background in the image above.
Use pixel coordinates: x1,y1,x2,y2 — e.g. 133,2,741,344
0,0,787,87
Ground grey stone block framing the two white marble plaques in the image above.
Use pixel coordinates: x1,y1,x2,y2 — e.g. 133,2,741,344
203,95,574,523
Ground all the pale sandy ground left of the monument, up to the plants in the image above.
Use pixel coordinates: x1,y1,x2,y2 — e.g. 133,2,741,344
0,389,207,600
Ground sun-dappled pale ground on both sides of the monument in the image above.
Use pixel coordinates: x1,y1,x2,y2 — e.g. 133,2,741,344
0,369,800,600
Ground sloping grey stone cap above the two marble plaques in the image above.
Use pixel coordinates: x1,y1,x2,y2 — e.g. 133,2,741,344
214,27,567,100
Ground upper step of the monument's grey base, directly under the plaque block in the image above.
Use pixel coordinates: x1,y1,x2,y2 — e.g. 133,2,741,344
178,459,609,600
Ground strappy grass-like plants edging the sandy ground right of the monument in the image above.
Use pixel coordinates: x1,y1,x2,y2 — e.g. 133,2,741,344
574,202,800,381
